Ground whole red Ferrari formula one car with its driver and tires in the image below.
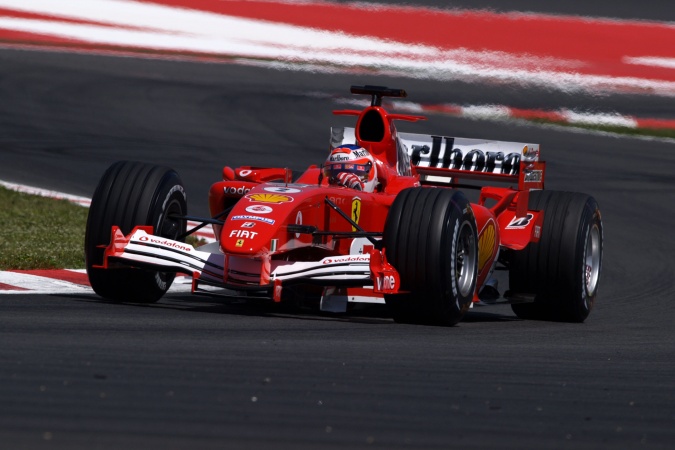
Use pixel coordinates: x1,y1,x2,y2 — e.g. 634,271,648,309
85,86,603,325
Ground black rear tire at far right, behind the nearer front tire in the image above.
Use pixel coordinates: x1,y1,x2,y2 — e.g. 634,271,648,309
508,191,603,322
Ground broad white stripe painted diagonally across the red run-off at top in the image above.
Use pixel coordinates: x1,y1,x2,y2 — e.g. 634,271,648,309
0,0,675,96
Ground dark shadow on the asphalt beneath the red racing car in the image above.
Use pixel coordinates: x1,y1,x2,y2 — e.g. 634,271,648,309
54,294,520,325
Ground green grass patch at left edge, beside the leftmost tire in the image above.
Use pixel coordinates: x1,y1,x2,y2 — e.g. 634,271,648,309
0,187,89,270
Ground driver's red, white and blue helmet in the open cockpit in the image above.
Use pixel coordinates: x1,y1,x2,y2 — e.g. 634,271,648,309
323,144,377,192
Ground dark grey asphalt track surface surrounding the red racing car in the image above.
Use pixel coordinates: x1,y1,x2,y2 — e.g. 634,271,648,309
0,5,675,449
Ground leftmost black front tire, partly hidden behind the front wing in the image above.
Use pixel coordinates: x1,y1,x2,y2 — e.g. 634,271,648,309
84,161,187,303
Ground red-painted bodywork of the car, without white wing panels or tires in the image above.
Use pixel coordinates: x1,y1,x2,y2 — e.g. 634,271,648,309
198,98,545,301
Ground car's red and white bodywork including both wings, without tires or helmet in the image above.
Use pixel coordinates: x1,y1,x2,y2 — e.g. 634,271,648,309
100,87,545,308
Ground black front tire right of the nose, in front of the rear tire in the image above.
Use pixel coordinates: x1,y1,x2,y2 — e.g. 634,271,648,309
383,188,478,326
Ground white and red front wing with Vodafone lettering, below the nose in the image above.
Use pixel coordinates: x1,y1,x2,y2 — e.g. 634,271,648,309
95,226,400,301
